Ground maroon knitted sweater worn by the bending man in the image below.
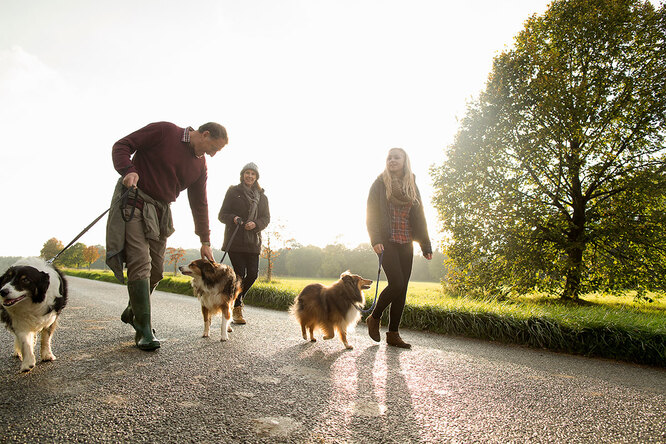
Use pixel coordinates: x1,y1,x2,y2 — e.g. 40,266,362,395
111,122,210,242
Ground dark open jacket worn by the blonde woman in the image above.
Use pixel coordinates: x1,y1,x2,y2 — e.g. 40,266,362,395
366,176,432,254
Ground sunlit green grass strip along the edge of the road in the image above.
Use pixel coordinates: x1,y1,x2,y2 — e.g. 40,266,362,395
64,269,666,366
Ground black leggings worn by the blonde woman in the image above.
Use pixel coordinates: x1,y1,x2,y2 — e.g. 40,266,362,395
372,242,414,331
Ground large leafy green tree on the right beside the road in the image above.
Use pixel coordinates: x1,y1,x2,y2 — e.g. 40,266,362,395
432,0,666,298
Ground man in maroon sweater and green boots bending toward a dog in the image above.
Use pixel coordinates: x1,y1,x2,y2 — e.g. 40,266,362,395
106,122,229,350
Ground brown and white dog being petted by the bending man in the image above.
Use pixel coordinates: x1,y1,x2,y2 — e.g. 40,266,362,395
179,259,241,341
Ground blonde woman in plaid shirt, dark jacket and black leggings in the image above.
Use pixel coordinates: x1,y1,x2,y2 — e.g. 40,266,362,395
366,148,432,348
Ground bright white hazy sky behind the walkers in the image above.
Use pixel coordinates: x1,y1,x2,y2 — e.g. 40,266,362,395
0,0,549,256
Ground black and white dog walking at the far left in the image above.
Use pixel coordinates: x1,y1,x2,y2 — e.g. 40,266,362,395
0,258,67,372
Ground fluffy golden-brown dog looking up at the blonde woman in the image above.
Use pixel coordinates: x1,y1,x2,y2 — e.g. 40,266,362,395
290,270,372,349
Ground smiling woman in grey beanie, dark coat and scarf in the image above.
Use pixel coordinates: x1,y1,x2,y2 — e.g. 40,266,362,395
218,162,271,324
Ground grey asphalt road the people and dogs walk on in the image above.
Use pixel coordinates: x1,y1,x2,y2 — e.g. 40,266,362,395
0,277,666,443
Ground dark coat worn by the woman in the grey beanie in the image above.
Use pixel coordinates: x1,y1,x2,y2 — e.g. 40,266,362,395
217,184,271,254
